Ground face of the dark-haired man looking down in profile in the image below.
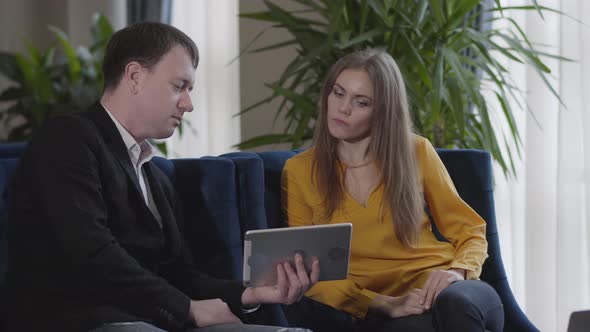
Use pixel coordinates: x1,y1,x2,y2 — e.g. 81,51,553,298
134,46,195,141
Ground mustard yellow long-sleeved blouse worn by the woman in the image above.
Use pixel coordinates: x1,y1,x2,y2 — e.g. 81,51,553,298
282,136,487,318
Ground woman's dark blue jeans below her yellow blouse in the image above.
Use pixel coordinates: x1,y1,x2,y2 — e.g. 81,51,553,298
284,280,504,332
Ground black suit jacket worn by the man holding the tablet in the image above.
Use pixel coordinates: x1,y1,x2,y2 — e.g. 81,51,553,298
6,104,243,331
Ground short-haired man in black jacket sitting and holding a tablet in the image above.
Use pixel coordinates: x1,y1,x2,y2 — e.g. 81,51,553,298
6,23,319,332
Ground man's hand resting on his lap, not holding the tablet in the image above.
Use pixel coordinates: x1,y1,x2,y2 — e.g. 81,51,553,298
189,299,242,327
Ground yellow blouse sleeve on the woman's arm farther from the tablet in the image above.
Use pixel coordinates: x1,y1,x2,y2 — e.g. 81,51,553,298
419,139,487,279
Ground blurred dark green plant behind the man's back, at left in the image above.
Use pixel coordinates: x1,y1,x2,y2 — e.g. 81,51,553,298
0,14,113,141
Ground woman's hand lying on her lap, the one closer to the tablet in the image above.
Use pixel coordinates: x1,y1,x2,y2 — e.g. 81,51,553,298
369,289,425,318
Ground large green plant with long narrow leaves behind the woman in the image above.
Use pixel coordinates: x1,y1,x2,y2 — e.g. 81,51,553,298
239,0,561,172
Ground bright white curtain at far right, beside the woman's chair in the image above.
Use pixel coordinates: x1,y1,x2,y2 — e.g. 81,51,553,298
495,0,590,331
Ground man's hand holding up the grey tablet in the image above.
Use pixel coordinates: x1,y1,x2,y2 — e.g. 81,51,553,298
242,254,320,305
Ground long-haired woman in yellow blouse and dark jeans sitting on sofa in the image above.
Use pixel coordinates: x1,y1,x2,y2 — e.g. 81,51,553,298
282,49,504,332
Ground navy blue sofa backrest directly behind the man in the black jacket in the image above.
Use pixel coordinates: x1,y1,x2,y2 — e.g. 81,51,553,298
0,154,242,284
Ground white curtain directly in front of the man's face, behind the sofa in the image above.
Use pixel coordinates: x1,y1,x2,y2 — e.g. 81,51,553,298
166,0,240,158
